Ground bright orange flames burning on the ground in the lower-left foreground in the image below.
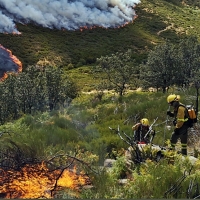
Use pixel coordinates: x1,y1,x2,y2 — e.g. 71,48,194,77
0,163,89,199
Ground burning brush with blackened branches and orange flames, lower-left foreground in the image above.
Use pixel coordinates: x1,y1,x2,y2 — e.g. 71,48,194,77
0,145,95,198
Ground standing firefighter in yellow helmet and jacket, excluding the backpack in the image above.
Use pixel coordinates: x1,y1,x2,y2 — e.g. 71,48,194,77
167,94,189,155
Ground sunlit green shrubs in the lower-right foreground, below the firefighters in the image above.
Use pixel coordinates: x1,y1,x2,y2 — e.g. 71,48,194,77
82,156,199,199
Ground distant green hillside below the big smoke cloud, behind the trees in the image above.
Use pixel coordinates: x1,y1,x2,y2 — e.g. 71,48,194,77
0,0,200,72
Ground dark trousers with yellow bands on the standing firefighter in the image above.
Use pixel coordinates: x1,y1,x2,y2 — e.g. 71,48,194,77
170,123,188,155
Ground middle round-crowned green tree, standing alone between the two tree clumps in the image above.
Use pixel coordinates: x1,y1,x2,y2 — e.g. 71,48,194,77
94,50,139,96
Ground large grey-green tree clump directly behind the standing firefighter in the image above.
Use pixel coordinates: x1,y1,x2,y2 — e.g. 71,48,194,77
141,36,200,92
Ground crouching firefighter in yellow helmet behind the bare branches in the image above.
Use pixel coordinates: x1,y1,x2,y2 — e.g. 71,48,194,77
132,118,153,144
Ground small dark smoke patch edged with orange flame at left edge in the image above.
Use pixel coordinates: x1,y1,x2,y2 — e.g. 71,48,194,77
0,45,22,78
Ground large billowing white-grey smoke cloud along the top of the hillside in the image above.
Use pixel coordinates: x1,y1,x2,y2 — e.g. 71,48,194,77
0,0,140,33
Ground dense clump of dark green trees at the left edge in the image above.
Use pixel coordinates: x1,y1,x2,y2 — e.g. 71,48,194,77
0,66,78,124
